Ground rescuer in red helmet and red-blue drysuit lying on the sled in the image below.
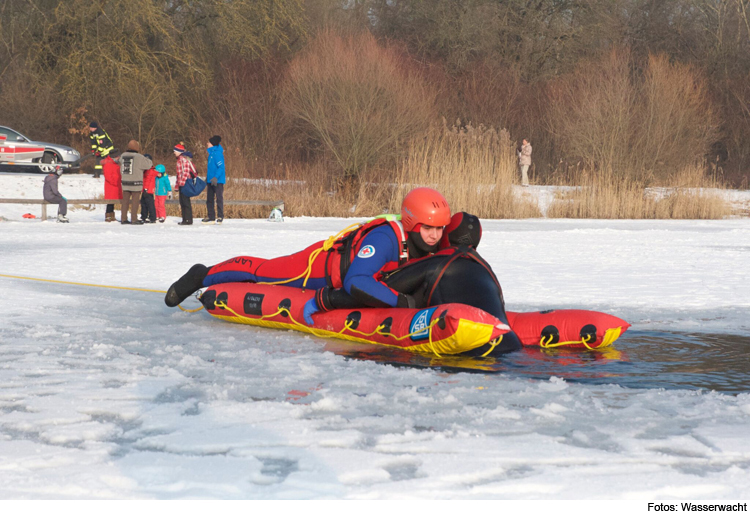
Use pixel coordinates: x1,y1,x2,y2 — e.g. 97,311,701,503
164,187,451,324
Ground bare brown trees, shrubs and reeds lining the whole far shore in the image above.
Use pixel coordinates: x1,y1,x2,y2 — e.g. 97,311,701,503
0,0,750,218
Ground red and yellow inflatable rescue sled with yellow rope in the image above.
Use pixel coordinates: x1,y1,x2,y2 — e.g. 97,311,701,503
201,282,630,356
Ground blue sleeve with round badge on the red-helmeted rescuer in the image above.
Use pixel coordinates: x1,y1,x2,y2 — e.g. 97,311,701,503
343,226,399,307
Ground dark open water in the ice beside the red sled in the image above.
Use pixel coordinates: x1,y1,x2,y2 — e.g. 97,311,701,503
338,330,750,394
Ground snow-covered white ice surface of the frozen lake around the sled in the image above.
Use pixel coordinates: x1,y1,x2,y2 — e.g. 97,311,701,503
0,172,750,501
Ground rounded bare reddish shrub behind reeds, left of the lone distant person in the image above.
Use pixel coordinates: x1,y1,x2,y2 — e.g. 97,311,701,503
283,31,435,184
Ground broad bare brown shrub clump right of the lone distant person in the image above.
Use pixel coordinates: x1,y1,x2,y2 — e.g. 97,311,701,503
548,50,716,184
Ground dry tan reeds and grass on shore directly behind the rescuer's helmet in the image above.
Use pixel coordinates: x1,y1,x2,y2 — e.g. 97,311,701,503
174,120,541,218
